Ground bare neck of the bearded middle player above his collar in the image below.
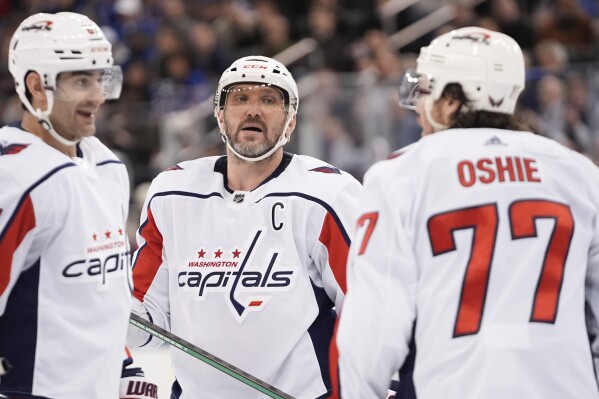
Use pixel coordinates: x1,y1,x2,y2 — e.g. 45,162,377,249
227,148,283,191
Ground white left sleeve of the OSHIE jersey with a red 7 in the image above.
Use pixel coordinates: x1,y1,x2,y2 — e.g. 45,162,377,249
331,163,417,399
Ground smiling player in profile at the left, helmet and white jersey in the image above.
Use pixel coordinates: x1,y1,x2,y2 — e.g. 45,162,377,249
0,12,157,399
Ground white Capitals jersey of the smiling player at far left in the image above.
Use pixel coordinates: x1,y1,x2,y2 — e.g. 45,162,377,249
0,127,132,399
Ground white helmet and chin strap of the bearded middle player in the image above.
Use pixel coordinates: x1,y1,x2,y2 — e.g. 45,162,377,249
214,56,299,162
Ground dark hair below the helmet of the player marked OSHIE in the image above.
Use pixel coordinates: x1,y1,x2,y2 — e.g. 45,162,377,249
442,83,531,131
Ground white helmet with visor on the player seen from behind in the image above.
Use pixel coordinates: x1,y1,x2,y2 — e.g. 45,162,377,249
400,27,524,114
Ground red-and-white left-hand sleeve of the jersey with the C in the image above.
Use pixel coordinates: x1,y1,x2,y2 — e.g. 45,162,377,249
127,182,170,347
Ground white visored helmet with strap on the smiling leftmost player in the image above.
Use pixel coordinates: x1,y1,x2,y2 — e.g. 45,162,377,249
8,12,123,145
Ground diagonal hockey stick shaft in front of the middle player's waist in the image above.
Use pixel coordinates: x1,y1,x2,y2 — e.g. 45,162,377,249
129,313,294,399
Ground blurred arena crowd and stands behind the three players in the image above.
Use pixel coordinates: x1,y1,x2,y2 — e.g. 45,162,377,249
0,0,599,398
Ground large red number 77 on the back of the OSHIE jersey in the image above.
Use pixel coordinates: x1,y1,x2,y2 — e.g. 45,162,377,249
427,200,574,337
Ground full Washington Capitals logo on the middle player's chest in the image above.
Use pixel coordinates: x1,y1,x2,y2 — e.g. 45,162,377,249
177,230,297,324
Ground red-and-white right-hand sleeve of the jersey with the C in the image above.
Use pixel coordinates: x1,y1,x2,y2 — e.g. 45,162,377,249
311,178,362,309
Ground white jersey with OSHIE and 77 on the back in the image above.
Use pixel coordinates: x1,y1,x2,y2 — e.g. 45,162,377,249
333,129,599,399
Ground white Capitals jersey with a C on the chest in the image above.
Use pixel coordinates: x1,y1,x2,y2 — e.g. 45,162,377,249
128,154,361,399
